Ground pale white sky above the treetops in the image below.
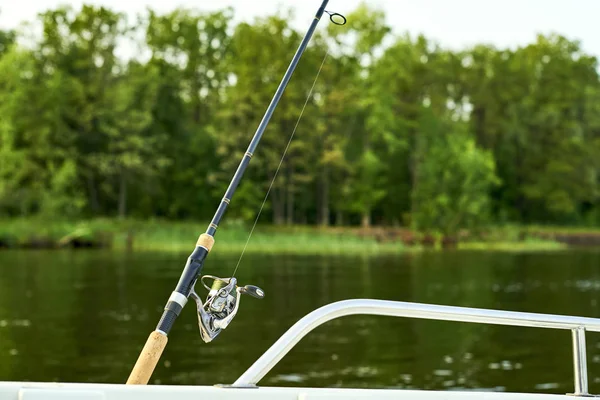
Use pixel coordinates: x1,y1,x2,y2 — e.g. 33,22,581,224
0,0,600,57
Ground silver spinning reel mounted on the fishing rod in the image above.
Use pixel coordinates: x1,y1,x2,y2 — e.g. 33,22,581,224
190,275,265,343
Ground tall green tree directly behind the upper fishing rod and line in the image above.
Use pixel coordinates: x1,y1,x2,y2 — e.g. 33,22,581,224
217,11,323,224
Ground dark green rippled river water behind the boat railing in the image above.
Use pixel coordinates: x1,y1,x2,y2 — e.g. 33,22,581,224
0,250,600,393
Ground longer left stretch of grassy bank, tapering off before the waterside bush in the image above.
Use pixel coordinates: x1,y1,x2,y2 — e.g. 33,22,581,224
0,219,406,254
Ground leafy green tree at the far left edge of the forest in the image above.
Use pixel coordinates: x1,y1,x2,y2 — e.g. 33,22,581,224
0,48,84,215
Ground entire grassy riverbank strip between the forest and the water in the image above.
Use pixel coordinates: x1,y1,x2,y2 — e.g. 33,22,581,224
0,218,600,255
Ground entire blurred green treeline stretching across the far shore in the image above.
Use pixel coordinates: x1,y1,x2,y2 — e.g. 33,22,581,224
0,5,600,233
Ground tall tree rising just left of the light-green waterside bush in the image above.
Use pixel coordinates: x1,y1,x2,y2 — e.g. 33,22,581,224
368,36,454,224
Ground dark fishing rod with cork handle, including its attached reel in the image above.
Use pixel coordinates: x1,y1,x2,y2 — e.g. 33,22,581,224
127,0,346,385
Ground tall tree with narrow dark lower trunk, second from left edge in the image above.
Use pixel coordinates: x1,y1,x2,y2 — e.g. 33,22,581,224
36,6,127,213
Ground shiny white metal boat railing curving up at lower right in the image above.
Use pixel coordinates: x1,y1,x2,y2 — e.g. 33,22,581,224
232,299,600,396
